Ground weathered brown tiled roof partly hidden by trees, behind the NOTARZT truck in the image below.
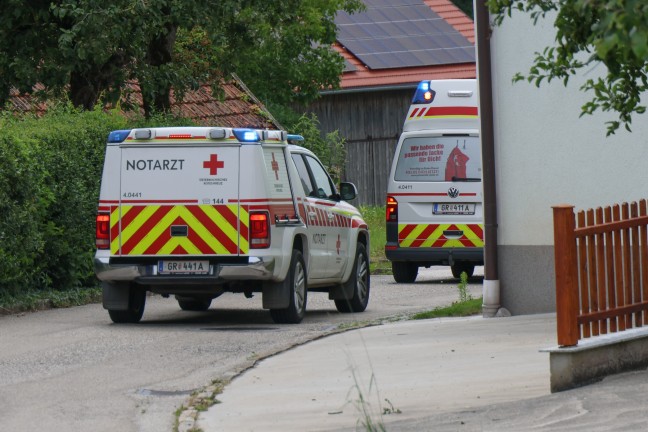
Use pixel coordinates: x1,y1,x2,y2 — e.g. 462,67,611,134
10,76,281,129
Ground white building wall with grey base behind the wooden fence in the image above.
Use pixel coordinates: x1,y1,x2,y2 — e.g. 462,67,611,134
491,13,648,313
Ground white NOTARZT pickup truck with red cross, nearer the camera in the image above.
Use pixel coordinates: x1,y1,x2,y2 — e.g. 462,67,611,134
94,127,370,323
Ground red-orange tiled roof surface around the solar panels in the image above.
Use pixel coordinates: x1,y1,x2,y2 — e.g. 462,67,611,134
333,0,477,90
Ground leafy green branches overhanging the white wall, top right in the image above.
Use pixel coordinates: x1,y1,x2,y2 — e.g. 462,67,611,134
486,0,648,135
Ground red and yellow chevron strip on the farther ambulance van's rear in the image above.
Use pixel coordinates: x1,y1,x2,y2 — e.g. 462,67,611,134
398,224,484,248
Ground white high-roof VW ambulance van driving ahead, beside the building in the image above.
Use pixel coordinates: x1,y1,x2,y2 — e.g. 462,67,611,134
385,79,484,282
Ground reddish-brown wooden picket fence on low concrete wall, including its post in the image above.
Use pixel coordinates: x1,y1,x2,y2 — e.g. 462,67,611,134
553,200,648,346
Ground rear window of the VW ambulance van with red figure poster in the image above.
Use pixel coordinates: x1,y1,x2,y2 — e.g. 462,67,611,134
394,136,482,182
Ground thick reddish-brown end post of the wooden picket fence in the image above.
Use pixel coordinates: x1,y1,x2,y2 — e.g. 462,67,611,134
552,204,580,346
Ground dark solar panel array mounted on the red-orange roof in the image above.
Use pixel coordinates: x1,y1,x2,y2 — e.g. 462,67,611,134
335,0,475,69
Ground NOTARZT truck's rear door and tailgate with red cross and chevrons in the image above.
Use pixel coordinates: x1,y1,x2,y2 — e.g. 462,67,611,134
110,138,244,257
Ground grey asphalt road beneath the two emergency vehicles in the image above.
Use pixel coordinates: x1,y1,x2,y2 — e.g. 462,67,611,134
0,267,483,432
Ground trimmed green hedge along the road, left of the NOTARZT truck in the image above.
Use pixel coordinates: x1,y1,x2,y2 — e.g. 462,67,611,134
0,107,128,294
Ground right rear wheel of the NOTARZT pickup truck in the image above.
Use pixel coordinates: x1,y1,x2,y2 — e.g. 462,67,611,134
270,249,308,324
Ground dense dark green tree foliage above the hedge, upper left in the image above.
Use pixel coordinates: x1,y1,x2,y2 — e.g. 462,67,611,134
0,0,362,114
